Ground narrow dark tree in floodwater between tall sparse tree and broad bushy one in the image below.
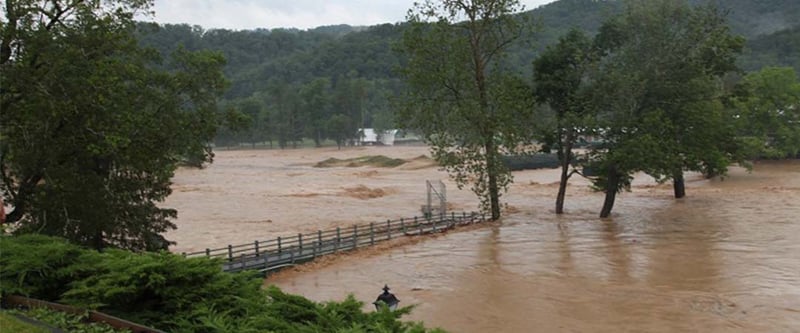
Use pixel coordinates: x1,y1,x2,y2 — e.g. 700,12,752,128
533,29,596,214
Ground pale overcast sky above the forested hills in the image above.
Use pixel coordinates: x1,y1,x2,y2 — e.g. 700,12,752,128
143,0,554,30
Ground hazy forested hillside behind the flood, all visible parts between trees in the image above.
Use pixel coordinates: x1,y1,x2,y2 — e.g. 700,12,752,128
134,0,800,147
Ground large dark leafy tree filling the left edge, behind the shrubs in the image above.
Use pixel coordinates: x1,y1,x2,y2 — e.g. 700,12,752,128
0,0,226,250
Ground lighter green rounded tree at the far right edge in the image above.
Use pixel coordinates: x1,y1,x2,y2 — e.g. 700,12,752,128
734,67,800,158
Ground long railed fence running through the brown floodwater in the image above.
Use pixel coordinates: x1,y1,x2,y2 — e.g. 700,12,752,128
184,212,486,272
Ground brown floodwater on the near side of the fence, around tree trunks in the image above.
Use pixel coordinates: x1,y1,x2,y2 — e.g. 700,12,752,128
266,162,800,332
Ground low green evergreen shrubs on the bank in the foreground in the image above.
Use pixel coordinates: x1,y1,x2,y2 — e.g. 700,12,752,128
0,235,444,332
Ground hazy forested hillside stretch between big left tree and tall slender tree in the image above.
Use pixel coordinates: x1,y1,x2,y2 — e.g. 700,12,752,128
138,24,402,148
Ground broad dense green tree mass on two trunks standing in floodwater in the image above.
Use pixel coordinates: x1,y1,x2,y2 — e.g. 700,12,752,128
595,0,743,217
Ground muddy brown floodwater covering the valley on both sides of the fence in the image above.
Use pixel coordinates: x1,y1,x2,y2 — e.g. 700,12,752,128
167,147,800,332
